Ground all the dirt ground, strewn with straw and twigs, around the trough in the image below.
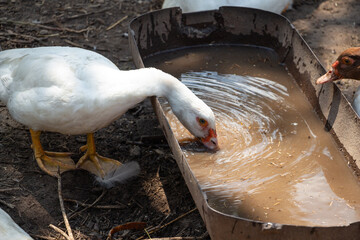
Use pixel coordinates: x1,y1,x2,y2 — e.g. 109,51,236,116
0,0,360,239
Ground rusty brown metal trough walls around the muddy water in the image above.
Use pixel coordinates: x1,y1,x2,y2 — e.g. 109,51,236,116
129,7,360,240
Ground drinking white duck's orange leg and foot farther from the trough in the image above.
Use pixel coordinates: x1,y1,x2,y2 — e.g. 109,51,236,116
30,129,75,177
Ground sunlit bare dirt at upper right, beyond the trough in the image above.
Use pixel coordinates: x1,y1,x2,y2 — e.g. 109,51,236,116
284,0,360,102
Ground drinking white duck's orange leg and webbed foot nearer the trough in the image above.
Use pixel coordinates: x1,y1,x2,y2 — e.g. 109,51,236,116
76,133,121,178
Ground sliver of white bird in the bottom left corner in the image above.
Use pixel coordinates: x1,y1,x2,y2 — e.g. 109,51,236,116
0,208,32,240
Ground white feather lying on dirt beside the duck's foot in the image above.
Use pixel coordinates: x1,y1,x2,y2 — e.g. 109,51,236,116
96,162,140,188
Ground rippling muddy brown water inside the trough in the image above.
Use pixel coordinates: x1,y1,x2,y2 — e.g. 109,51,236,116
145,46,360,226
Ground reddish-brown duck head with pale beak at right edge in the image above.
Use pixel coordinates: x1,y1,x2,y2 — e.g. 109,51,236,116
316,47,360,84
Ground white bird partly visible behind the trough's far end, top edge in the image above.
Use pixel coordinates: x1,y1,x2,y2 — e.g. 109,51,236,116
162,0,293,14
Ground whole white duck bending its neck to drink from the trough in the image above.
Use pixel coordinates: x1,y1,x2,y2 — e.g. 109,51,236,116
0,47,218,177
